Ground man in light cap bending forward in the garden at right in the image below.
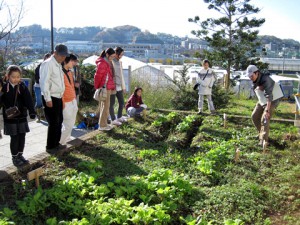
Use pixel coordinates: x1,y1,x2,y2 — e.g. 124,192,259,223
247,65,280,145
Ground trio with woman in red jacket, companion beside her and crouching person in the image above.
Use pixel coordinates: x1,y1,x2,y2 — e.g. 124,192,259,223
94,47,147,130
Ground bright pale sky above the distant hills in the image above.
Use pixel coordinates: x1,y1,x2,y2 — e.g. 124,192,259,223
0,0,300,41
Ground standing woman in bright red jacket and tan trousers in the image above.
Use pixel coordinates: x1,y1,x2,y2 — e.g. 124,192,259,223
94,48,116,130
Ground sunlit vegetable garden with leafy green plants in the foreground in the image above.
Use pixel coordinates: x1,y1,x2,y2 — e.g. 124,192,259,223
0,100,300,225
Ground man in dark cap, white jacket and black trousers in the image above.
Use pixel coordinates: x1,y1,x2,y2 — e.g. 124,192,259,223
40,44,69,153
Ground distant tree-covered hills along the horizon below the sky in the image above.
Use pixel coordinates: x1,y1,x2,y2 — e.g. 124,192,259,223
14,24,300,49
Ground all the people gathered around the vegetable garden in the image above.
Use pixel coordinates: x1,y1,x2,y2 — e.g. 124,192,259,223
0,44,283,167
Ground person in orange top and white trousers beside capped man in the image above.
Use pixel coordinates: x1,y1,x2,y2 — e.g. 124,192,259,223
59,54,78,145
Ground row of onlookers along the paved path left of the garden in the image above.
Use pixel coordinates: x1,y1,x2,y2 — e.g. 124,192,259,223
0,44,147,167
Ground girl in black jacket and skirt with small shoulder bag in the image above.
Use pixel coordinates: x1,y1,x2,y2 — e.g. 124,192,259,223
1,65,36,167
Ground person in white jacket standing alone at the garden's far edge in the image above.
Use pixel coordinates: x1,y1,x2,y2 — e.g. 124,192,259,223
197,59,216,114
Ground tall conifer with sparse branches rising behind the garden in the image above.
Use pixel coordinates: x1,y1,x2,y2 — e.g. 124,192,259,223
189,0,265,89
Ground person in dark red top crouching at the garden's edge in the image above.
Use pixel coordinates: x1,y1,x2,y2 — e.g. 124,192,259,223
125,87,147,117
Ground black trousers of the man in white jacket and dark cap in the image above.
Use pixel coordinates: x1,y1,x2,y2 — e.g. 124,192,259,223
43,96,63,149
